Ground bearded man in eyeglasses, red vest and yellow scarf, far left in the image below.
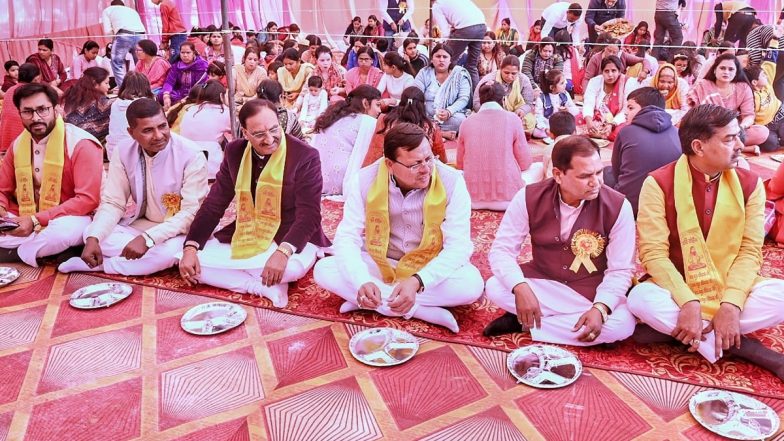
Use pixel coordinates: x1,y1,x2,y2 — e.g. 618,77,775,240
0,83,103,266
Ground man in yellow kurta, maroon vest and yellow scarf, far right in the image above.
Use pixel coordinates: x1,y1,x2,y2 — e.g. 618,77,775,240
628,104,784,380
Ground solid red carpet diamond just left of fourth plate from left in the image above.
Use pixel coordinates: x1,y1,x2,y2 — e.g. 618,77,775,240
267,327,346,389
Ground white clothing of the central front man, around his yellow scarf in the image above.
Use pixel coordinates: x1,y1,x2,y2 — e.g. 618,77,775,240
313,159,484,330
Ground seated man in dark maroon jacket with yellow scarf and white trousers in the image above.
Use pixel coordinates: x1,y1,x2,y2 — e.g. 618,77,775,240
180,99,330,308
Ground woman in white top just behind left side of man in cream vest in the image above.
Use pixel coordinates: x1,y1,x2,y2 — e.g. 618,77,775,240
106,70,155,159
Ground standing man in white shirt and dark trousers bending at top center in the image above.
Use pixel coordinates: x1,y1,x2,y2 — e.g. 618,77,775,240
430,0,487,93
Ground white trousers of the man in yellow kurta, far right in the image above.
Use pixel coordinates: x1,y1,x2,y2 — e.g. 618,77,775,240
628,279,784,363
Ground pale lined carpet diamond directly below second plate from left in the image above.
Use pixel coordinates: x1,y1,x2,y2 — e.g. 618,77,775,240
37,326,142,394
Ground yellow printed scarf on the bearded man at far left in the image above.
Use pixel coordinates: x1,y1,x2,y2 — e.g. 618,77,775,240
14,117,65,216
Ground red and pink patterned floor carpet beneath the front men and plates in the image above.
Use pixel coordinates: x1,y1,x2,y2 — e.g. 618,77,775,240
0,152,784,441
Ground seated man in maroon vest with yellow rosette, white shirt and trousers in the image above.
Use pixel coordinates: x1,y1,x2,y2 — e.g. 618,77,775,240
484,136,635,346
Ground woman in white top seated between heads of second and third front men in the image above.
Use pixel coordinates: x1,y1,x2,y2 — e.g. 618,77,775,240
168,80,231,179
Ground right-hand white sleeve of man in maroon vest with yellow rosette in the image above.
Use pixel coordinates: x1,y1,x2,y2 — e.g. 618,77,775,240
594,200,637,310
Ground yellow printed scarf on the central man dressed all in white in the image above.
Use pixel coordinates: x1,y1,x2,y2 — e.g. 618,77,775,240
365,160,446,283
